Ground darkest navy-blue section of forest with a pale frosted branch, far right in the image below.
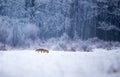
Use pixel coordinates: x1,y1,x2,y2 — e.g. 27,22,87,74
94,0,120,40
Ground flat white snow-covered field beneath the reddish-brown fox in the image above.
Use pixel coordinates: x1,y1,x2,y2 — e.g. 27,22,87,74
0,49,120,77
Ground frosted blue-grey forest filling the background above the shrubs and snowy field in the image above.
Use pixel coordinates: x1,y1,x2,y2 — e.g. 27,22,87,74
0,0,120,50
